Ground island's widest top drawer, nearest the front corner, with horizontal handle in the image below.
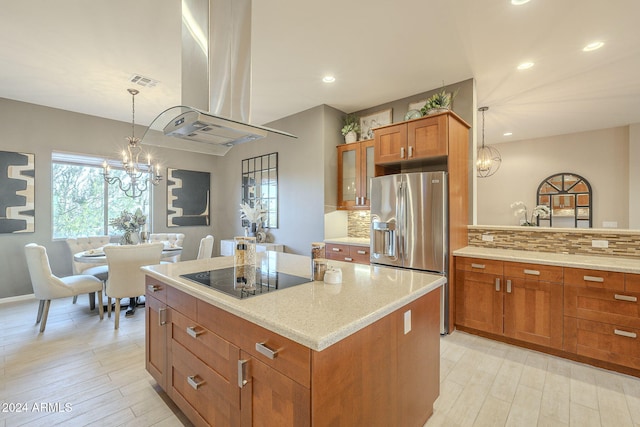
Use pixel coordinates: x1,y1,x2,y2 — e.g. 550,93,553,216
197,300,311,388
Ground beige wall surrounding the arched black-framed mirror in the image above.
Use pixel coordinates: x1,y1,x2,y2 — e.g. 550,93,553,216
477,126,637,228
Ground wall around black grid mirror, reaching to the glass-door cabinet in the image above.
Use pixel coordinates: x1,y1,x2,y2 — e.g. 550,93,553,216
212,105,343,255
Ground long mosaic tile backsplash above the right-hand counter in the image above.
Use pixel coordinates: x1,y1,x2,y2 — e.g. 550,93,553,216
467,225,640,260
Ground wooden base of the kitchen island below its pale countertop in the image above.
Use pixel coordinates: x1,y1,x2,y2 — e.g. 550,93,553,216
145,277,440,427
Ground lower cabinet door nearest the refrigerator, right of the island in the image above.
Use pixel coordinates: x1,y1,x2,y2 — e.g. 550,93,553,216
455,269,503,334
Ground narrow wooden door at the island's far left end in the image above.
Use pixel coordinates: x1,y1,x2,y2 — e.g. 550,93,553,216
145,293,168,390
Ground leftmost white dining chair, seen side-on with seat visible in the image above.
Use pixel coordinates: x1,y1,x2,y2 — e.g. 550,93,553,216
24,243,103,332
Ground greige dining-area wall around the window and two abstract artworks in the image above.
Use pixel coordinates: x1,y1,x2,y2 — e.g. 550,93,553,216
0,98,220,298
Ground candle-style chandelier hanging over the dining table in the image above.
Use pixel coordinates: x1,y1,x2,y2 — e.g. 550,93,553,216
102,89,162,198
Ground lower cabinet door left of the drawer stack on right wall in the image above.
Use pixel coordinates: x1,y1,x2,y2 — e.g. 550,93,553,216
504,278,563,350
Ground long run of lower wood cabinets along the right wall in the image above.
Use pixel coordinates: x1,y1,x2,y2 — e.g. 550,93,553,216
455,257,640,376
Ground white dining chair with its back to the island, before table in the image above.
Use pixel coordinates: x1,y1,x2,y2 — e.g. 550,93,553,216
104,242,164,329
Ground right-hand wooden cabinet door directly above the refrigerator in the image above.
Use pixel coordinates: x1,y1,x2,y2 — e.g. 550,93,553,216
407,114,449,160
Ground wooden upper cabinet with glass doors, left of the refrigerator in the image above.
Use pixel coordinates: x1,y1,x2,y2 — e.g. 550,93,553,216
338,139,375,210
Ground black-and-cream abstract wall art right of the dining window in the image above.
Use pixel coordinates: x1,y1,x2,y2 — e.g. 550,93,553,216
167,168,211,227
